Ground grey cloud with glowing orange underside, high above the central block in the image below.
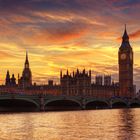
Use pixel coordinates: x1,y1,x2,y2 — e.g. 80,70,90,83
26,22,89,45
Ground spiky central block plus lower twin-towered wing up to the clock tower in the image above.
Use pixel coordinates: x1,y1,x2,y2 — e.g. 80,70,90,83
60,69,119,98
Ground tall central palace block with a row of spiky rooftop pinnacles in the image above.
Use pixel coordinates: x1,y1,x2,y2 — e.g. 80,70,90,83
60,69,91,95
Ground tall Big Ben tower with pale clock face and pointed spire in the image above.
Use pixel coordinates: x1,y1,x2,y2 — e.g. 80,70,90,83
118,26,134,98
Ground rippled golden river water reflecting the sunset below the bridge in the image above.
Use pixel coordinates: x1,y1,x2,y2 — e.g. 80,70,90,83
0,109,140,140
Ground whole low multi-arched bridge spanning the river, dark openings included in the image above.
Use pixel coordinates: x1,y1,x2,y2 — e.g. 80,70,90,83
0,93,140,111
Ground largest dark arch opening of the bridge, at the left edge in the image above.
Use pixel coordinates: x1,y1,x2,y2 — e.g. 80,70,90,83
0,98,39,112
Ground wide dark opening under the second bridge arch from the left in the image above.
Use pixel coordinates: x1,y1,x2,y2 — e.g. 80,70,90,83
45,98,81,110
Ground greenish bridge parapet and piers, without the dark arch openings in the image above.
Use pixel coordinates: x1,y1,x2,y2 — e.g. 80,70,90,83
0,93,140,110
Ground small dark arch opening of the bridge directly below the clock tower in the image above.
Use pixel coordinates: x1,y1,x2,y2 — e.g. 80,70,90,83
111,98,128,108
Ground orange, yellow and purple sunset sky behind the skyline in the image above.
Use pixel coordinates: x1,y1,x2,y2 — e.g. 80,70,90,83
0,0,140,87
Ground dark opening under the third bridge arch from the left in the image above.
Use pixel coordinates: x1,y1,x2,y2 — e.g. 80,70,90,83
86,99,109,109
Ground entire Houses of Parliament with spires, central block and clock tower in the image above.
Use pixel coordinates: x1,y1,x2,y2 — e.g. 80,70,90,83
0,27,136,98
